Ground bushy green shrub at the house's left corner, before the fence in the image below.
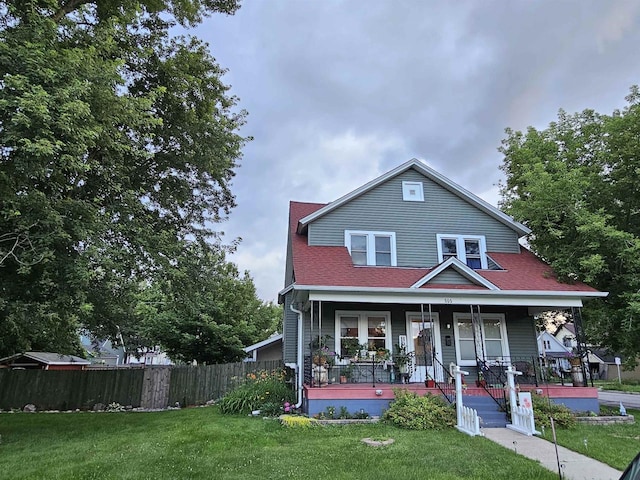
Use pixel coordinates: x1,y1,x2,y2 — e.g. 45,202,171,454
218,370,295,416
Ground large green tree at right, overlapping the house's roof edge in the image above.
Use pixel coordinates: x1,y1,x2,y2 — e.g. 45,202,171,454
500,86,640,364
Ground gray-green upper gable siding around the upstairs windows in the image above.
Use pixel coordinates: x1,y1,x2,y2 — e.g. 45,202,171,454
308,169,520,267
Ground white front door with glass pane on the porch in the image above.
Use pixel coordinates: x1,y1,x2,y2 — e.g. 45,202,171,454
407,313,444,382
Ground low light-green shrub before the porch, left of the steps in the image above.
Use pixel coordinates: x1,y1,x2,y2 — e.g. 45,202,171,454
382,389,456,430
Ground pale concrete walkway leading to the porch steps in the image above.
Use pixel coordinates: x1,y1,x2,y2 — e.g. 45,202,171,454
482,428,622,480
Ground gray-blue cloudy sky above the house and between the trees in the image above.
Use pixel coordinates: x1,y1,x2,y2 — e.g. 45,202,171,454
193,0,640,300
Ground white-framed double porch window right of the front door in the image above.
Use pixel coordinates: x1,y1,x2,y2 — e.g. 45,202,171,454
453,313,509,366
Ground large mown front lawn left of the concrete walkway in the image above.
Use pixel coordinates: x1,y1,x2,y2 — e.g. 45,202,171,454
0,408,556,480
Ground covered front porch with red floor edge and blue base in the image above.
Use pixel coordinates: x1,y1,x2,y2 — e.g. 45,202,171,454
294,290,598,415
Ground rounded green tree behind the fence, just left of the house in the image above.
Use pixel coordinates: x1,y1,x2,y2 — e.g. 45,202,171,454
134,242,282,364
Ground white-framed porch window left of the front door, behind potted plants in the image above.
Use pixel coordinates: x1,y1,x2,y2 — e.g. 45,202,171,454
336,311,391,356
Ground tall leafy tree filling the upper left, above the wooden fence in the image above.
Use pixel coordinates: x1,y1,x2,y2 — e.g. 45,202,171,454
0,0,245,357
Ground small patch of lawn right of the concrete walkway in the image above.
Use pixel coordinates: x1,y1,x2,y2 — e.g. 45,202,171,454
544,410,640,470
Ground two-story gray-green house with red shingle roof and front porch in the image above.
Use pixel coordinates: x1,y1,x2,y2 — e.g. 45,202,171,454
279,160,606,414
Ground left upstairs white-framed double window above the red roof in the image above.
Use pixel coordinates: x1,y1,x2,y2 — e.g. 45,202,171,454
344,230,396,267
